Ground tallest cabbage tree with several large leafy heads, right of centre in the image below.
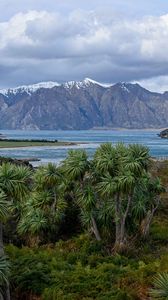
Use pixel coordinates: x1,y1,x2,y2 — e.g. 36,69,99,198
93,144,149,251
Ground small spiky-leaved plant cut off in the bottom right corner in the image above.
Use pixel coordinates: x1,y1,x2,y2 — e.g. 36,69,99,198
150,273,168,300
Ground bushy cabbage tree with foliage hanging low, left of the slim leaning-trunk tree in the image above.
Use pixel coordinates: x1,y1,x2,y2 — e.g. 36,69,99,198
18,163,66,245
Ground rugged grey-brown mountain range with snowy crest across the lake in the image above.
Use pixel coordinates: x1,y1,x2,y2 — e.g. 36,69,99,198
0,78,168,130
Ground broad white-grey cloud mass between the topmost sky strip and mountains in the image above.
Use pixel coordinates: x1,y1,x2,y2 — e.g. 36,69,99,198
0,10,168,88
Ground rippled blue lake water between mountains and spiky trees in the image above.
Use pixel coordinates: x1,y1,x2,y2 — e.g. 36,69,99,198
0,130,168,165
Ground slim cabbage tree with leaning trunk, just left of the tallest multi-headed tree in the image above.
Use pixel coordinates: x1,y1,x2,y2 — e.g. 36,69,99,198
62,150,101,241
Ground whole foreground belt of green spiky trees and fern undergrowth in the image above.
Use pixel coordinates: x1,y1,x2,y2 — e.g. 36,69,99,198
0,144,168,300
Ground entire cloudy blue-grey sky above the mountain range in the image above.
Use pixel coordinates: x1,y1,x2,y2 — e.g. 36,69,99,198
0,0,168,91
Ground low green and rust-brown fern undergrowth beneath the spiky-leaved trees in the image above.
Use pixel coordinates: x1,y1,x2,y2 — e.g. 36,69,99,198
6,235,168,300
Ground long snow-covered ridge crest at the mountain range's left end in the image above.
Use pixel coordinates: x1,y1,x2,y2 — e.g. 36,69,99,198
0,81,60,96
